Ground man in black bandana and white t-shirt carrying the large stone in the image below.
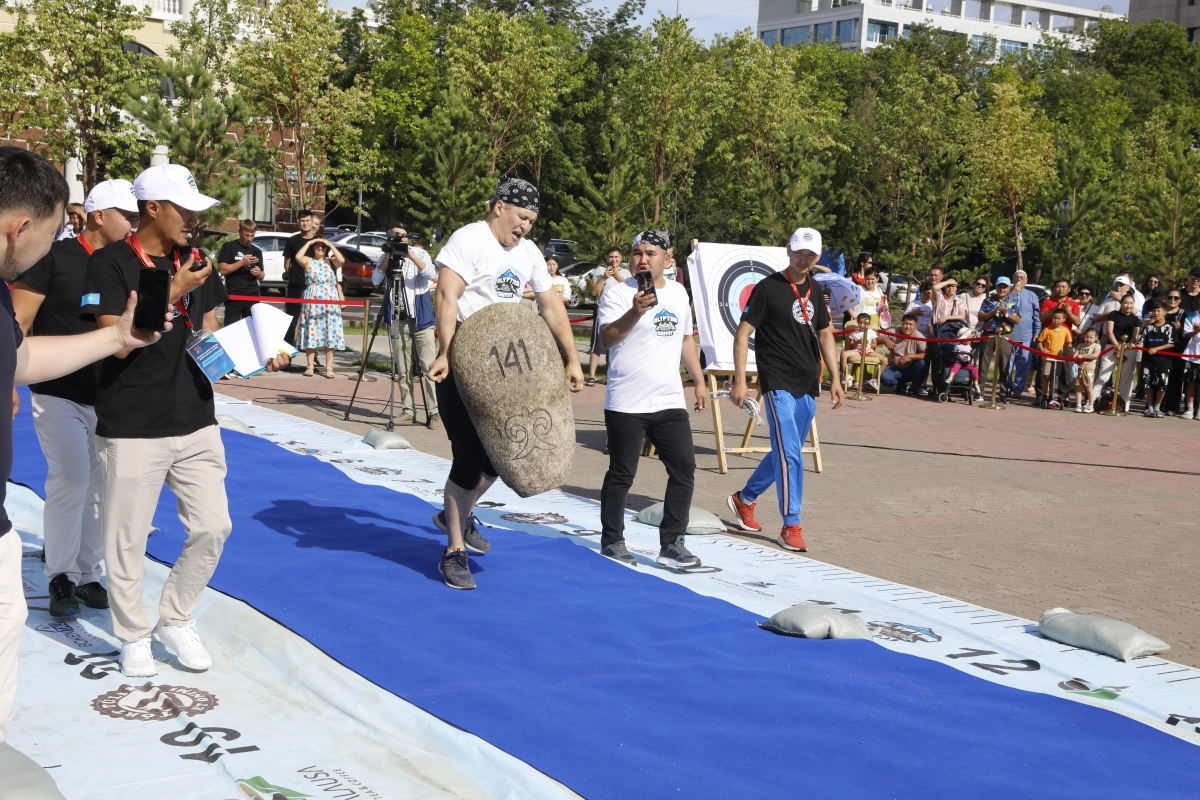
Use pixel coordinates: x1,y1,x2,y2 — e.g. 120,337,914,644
428,178,583,589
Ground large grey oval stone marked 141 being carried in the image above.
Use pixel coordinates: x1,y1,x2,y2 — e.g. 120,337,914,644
450,302,575,498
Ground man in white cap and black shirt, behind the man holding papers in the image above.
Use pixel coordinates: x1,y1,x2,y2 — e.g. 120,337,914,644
12,180,138,616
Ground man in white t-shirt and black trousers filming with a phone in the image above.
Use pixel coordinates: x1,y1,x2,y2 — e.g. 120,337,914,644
596,230,708,569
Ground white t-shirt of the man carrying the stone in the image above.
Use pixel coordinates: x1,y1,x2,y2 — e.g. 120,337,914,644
437,222,551,323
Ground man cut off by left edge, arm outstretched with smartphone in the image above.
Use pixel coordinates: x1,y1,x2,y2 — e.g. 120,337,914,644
0,146,169,798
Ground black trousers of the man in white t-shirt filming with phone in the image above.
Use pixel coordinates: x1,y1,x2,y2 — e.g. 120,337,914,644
600,408,696,547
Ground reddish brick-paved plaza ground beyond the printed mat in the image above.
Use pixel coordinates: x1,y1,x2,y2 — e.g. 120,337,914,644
217,354,1200,667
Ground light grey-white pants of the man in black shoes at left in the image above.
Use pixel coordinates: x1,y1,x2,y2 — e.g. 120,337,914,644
32,392,104,587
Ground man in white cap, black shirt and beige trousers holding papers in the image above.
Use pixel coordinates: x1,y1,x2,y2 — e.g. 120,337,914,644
82,164,288,678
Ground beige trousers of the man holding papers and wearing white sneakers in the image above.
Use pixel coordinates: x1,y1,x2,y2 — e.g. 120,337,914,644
98,425,233,642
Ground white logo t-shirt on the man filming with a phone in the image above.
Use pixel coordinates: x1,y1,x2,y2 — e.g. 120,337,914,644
598,278,691,414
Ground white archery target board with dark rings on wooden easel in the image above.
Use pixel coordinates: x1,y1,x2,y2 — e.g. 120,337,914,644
692,243,787,369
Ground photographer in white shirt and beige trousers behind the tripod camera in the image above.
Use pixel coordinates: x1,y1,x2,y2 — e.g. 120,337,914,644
371,228,442,431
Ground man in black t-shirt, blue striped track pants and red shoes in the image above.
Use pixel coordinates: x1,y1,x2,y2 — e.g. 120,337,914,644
728,228,844,551
